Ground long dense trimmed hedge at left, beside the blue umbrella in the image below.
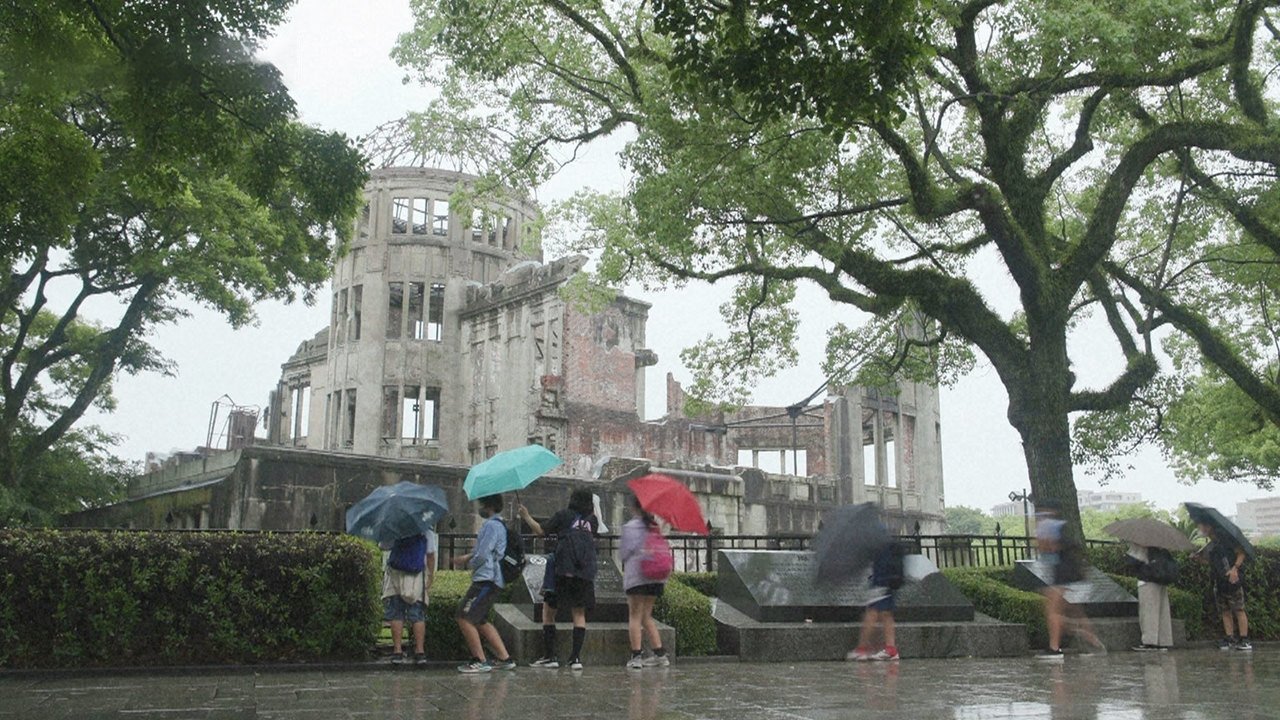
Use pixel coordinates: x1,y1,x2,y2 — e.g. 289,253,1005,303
0,530,381,667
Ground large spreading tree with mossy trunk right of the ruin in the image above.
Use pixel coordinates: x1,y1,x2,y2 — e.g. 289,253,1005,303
396,0,1280,532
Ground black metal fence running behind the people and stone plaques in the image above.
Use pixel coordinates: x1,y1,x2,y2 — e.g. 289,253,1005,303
439,533,1111,573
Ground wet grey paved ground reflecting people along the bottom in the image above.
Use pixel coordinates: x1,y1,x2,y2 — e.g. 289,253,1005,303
0,647,1280,720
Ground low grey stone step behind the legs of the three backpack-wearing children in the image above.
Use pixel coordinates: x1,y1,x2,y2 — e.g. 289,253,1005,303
494,603,680,667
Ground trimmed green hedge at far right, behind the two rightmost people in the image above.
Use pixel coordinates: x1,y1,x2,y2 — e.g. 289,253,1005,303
1088,544,1280,641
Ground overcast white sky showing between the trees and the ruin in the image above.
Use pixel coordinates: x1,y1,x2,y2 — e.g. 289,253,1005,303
92,0,1274,514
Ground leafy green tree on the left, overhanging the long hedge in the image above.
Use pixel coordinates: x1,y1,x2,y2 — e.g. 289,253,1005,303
0,0,366,515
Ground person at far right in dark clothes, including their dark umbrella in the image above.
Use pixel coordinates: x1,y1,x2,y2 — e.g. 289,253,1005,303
1185,502,1254,651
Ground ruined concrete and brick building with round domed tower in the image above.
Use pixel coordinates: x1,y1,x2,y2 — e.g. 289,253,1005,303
69,168,943,534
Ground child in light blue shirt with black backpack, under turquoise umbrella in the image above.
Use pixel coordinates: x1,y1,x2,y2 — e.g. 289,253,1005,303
453,495,516,674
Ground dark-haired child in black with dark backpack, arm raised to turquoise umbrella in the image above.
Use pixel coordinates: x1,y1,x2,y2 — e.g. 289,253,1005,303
520,488,600,670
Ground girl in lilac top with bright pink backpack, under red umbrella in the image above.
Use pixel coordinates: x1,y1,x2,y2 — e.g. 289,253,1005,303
618,496,675,670
